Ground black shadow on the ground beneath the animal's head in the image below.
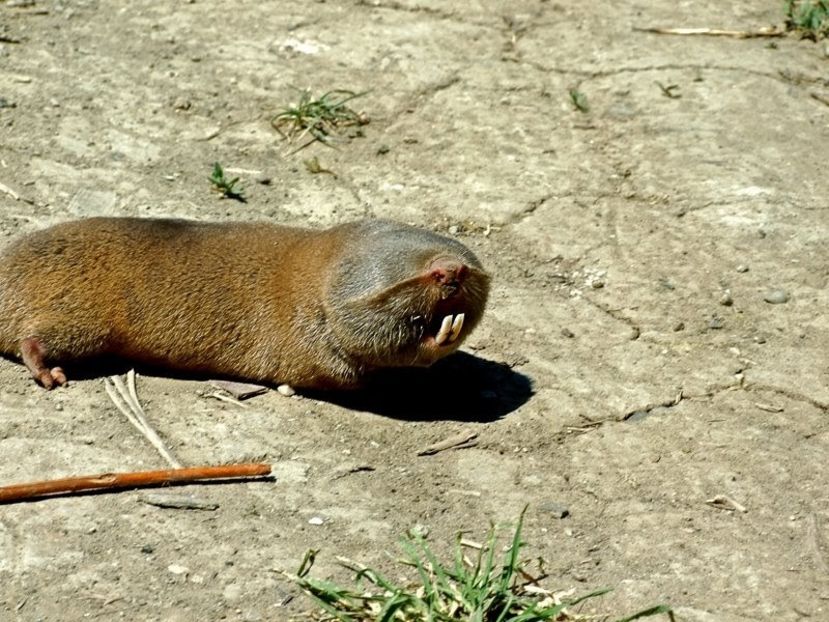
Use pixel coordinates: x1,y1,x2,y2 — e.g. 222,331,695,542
303,352,533,422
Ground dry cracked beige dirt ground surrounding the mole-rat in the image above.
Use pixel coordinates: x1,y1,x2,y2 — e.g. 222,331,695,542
0,0,829,622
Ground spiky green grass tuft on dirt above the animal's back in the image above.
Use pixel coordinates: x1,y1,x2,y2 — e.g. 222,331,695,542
271,89,368,147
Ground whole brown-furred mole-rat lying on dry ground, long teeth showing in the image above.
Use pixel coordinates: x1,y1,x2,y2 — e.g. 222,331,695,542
0,218,489,389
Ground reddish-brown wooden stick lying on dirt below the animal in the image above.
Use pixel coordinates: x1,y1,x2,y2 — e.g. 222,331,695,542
0,464,271,503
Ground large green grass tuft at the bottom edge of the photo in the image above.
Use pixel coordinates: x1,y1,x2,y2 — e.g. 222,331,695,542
283,508,674,622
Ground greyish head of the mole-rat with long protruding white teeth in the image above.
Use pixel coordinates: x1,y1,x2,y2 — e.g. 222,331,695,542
326,221,490,367
